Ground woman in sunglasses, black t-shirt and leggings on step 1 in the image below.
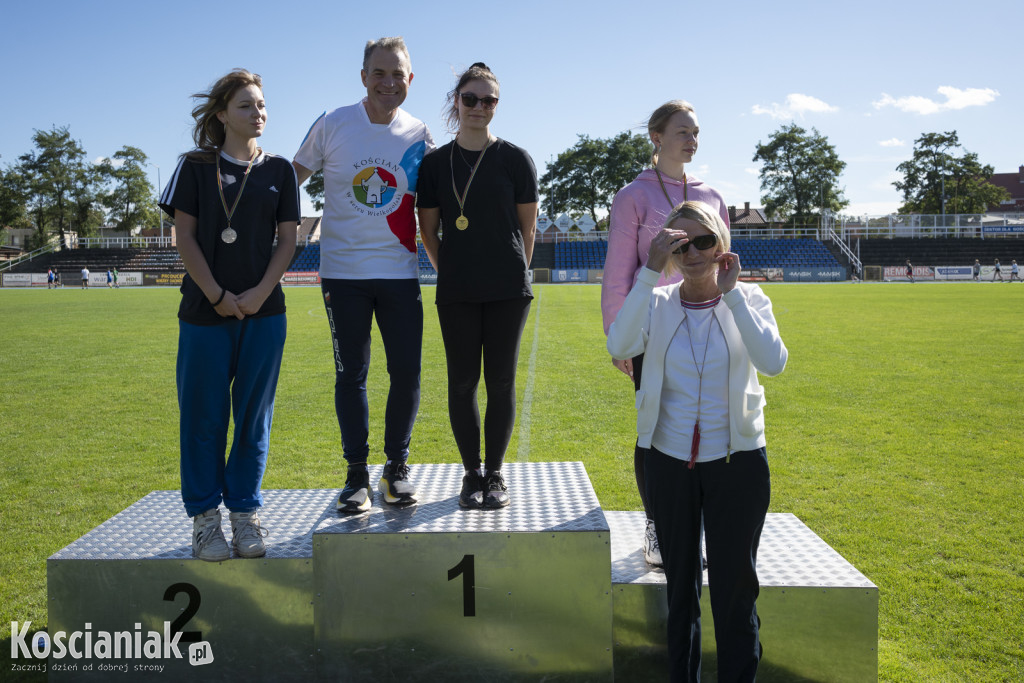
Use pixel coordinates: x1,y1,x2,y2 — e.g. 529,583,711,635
417,62,538,508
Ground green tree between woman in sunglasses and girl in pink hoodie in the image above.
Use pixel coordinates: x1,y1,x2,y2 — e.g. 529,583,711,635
540,132,653,222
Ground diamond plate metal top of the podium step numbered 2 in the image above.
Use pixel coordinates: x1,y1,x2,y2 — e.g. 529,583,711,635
49,488,341,562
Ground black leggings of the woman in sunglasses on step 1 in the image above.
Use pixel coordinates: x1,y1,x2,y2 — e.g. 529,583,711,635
437,298,530,470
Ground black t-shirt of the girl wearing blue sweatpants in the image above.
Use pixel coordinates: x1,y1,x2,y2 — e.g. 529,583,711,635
160,154,299,325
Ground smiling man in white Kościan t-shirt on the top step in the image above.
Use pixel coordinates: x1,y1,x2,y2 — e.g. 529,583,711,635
292,38,434,513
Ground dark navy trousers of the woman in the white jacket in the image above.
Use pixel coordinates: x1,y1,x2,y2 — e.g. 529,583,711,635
645,447,771,683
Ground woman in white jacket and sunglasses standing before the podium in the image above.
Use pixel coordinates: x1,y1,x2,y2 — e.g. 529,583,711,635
608,202,787,682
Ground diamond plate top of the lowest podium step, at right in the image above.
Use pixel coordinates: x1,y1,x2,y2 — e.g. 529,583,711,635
604,511,877,588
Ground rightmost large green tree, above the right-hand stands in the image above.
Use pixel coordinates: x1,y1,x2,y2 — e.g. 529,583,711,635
893,130,1010,214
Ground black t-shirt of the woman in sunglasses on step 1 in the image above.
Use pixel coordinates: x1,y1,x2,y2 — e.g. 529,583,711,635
416,138,538,304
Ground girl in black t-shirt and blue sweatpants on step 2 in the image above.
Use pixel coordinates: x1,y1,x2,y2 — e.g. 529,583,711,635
160,70,299,561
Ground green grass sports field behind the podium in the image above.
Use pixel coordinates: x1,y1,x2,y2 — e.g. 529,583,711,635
0,283,1024,682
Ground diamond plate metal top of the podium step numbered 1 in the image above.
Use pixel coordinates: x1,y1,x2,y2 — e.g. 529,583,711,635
315,462,608,533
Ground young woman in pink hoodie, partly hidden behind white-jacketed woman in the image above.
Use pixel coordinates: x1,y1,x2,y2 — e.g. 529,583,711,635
601,99,729,566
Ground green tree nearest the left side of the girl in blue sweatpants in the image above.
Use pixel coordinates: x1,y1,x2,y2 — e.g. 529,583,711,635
99,145,160,231
